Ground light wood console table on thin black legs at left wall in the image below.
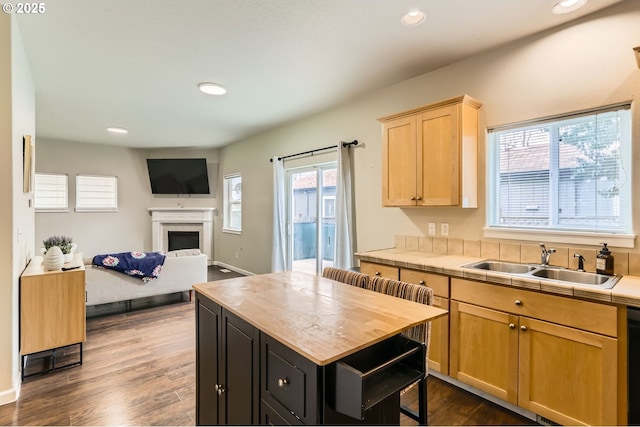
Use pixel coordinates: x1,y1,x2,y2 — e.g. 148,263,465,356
20,253,86,379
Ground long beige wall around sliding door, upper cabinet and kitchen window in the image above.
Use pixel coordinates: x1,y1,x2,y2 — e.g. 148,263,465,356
215,1,640,273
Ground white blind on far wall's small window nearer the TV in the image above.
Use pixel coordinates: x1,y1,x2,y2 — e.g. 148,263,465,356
76,175,118,212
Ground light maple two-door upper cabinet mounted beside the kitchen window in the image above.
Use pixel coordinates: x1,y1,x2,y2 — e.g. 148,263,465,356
378,95,482,208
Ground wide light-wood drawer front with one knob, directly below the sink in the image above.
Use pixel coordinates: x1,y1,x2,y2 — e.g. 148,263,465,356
451,278,618,337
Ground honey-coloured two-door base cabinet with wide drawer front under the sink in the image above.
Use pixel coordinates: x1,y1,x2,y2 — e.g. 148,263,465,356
449,278,626,425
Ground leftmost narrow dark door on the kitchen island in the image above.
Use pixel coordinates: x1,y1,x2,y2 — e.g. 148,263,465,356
196,293,222,425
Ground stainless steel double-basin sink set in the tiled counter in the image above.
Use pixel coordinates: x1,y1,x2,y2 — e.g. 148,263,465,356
462,260,620,289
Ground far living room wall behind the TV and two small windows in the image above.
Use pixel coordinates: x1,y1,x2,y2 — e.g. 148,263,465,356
35,139,218,258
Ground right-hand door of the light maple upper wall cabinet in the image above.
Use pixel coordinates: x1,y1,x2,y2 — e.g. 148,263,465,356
417,105,460,206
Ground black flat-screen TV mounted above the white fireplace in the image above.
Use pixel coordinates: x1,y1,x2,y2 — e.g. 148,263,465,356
147,159,209,194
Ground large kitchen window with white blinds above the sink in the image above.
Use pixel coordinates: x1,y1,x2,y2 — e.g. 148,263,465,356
488,104,631,234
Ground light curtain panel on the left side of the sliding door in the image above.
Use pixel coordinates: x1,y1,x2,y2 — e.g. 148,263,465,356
271,156,287,273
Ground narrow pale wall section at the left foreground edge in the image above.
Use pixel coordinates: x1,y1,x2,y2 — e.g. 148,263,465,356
0,14,35,405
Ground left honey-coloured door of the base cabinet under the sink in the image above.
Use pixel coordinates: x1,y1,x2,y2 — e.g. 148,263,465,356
449,301,518,405
